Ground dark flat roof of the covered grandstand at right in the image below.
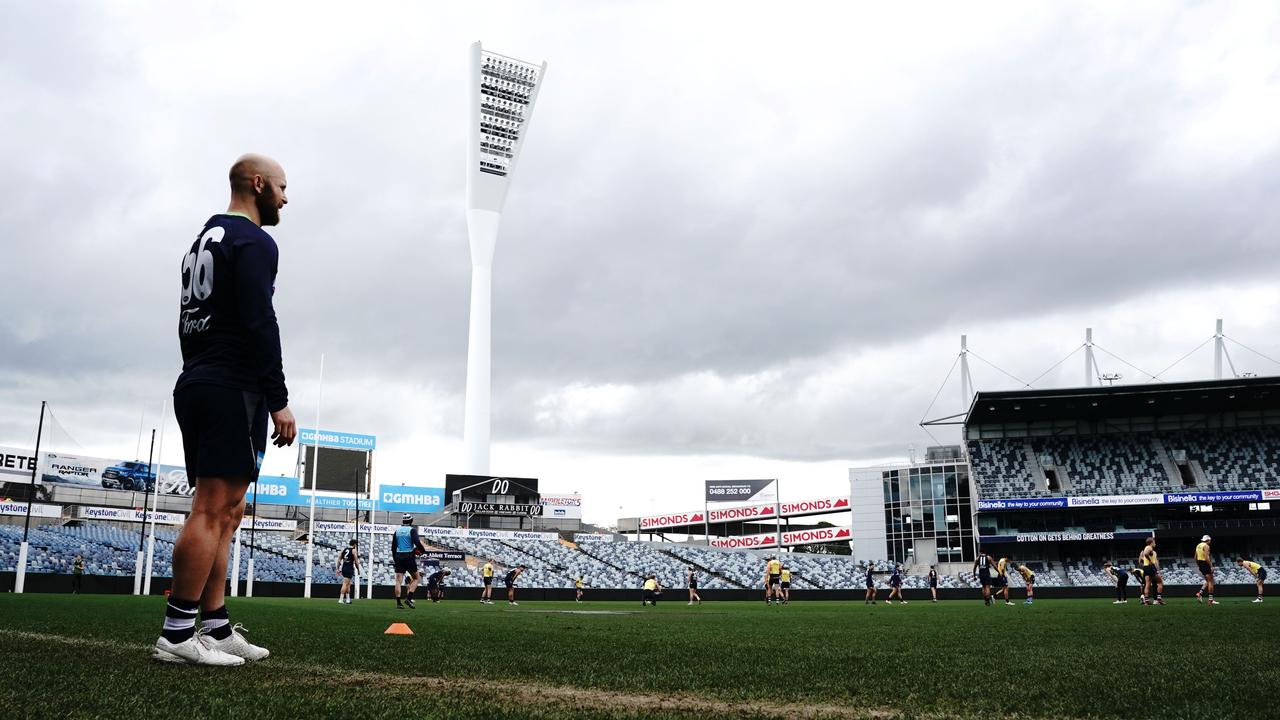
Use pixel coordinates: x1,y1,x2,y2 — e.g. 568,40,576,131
965,377,1280,425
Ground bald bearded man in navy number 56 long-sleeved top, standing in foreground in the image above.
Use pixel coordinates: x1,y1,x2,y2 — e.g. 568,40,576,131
151,155,297,665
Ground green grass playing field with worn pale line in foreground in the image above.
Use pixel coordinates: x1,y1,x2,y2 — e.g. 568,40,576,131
0,591,1280,720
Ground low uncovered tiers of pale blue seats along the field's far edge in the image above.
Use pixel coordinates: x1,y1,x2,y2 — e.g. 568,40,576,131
0,523,1280,591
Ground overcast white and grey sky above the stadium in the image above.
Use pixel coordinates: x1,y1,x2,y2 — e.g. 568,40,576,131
0,1,1280,524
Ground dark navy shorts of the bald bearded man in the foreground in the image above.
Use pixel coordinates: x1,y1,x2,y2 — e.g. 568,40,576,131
173,383,268,479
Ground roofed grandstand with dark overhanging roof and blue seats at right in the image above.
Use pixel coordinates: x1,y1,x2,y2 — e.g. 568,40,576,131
964,378,1280,573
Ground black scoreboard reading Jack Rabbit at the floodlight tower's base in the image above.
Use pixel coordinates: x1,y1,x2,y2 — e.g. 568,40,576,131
444,475,543,530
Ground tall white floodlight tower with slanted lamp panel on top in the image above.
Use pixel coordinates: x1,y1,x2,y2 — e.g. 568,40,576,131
462,42,547,475
